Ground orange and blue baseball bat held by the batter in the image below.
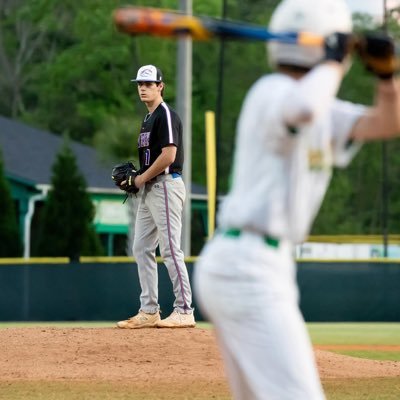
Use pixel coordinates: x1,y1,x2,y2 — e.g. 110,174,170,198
113,6,324,46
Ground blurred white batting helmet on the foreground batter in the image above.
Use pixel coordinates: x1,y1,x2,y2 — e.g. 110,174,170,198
267,0,352,68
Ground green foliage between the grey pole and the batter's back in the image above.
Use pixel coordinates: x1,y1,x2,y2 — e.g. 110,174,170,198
192,0,278,189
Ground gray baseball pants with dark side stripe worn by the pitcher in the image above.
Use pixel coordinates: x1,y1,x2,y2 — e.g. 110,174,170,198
133,174,193,314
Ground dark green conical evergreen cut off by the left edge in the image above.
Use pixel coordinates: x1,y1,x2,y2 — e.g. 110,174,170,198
0,150,22,257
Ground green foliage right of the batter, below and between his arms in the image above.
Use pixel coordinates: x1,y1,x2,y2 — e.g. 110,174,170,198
312,52,400,235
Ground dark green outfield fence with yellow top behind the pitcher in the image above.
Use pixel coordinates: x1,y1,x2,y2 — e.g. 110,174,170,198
0,257,400,322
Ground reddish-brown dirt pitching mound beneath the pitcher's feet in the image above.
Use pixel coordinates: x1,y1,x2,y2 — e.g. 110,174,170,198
0,328,400,390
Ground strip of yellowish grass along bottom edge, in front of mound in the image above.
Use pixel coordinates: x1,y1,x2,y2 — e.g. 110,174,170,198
0,378,400,400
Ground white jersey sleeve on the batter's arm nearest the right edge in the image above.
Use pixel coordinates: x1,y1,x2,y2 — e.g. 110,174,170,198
331,100,367,168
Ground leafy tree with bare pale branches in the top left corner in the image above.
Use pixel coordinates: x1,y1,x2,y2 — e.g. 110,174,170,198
0,0,69,118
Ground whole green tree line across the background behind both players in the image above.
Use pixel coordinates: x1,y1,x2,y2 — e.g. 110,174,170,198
0,0,400,256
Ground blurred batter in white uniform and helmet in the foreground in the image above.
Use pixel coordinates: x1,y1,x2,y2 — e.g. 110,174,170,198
195,0,400,400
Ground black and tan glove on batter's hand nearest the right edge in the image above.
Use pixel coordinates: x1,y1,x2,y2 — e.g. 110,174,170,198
357,33,399,79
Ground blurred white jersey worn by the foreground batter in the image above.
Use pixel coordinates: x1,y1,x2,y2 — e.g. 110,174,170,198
218,66,366,243
